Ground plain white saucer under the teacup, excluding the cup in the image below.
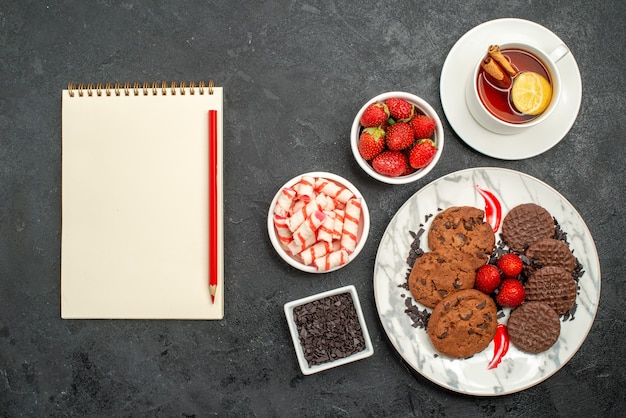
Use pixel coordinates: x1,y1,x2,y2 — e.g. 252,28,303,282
440,19,582,160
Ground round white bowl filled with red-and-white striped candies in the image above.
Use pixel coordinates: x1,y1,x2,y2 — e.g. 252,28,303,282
267,171,370,273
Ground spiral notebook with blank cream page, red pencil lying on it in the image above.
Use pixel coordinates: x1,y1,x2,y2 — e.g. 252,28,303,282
61,82,224,319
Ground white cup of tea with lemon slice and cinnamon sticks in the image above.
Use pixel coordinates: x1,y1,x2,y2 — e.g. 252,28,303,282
465,42,569,135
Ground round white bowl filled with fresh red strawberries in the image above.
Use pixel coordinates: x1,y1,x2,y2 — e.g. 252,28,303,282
350,91,444,184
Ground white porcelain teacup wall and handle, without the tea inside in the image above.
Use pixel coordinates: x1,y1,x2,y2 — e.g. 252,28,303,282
465,42,570,135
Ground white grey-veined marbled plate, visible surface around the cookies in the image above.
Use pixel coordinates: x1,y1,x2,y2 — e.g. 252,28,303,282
374,168,600,396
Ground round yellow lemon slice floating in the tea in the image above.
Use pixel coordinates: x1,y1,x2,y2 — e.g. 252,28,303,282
511,71,552,115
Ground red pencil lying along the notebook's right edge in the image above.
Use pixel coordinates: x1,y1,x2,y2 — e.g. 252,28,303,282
209,110,219,303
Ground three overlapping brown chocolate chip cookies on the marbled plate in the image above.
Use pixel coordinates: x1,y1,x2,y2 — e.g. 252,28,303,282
408,206,498,358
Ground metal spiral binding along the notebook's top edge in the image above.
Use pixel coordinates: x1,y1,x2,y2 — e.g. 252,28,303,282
67,80,215,97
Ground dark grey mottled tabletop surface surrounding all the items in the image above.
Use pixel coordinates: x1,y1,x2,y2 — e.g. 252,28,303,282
0,0,626,417
